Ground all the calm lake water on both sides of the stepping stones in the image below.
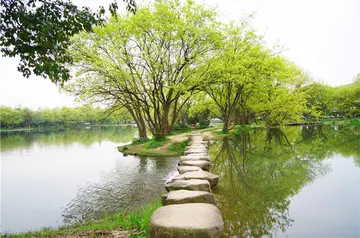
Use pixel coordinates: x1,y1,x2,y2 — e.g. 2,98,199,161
0,126,360,238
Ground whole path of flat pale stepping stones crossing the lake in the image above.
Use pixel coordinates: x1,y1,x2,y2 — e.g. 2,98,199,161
150,133,224,238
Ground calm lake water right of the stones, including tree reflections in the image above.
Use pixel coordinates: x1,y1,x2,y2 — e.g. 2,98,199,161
210,126,360,238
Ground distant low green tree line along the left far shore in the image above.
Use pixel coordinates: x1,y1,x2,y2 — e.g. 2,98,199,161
0,105,132,128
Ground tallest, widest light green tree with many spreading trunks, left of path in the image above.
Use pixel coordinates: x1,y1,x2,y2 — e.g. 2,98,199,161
66,0,219,139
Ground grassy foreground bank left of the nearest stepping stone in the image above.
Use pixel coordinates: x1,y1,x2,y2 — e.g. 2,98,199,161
1,201,161,238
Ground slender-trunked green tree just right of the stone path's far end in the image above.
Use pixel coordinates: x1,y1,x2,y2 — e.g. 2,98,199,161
202,21,269,133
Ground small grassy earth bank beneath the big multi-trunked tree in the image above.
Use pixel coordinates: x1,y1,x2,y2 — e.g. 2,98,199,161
118,128,217,157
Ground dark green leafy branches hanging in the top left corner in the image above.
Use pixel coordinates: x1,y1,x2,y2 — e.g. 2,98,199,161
0,0,136,83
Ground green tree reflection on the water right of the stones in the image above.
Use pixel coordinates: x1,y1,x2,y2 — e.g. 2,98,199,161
210,126,360,237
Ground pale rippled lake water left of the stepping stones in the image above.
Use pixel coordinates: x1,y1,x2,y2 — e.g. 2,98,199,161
0,127,178,232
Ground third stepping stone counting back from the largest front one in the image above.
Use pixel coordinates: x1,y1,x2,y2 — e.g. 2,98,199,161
165,179,211,192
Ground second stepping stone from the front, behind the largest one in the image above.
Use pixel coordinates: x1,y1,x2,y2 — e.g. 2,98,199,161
163,190,216,206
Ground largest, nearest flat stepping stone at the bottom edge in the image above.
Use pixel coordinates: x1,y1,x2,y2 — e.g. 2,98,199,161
150,203,224,238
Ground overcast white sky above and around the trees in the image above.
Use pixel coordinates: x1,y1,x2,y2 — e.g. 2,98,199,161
0,0,360,108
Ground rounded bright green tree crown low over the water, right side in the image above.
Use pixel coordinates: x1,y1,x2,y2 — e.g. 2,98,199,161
249,57,309,126
